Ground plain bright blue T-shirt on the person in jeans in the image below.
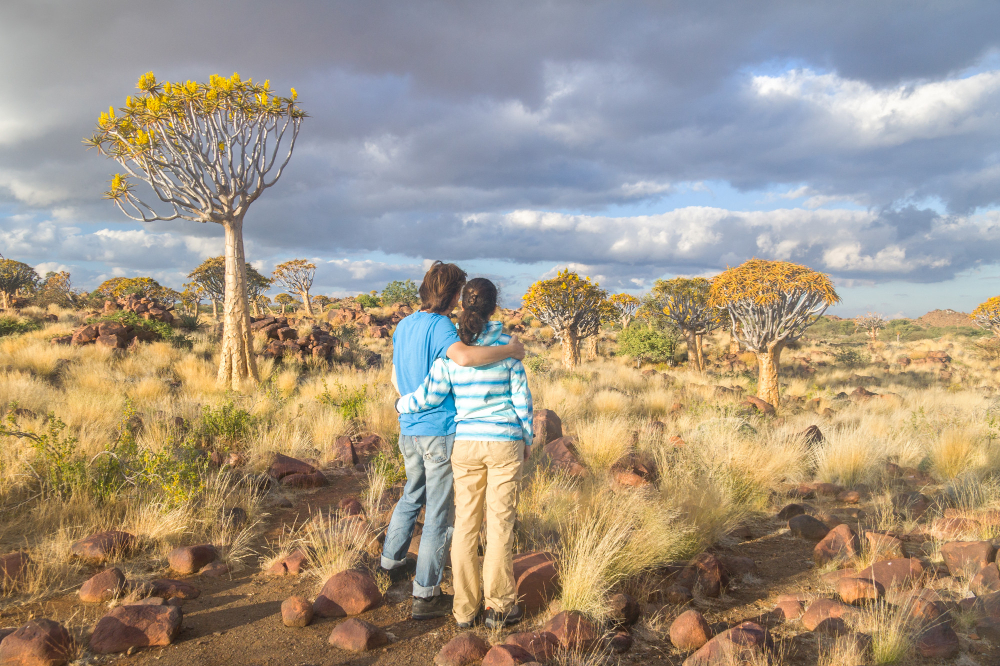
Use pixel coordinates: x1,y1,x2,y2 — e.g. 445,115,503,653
392,312,460,437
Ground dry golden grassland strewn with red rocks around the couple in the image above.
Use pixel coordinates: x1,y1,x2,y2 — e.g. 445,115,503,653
0,307,1000,666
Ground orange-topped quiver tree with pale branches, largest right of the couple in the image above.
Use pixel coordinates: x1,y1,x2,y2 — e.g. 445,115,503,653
710,259,840,407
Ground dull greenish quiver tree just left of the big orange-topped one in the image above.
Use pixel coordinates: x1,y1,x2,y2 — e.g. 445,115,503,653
647,278,722,372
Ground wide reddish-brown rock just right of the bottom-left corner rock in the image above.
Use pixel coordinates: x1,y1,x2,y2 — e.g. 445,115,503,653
90,604,181,654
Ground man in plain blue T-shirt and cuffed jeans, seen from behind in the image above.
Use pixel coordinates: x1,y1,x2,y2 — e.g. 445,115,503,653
380,261,524,620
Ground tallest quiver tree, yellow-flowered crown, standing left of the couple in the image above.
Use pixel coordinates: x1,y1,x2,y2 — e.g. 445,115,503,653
85,72,306,389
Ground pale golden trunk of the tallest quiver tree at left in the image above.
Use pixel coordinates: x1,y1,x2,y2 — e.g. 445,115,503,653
219,218,258,390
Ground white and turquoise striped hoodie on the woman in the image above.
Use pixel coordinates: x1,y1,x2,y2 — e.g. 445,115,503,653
396,321,533,446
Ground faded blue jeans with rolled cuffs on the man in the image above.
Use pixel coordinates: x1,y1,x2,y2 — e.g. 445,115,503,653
382,435,455,598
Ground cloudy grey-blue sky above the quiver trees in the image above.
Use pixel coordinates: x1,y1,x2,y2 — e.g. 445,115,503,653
0,0,1000,317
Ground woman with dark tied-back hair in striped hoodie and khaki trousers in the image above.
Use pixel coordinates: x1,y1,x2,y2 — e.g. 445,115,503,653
396,278,533,629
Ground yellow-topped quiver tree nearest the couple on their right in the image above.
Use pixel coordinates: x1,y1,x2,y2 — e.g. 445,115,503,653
523,269,607,368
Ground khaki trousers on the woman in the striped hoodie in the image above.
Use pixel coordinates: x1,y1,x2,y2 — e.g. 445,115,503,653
451,440,524,622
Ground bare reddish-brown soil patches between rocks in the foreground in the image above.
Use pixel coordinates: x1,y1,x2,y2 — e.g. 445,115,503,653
0,475,1000,666
